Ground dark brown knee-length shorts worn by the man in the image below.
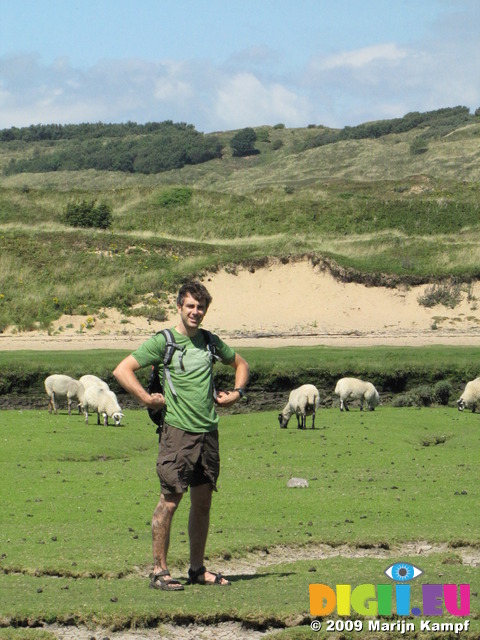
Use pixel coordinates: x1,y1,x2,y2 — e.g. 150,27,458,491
157,424,220,493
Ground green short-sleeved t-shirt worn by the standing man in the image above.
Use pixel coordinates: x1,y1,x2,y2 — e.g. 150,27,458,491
132,329,235,433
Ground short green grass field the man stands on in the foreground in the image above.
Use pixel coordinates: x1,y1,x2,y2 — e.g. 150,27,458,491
0,407,480,639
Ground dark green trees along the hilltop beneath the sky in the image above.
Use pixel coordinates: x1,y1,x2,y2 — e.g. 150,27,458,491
0,106,480,175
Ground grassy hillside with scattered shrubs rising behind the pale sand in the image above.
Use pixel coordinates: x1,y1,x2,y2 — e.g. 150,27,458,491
0,112,480,330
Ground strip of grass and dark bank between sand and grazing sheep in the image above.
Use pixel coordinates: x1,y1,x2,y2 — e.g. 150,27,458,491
0,347,472,413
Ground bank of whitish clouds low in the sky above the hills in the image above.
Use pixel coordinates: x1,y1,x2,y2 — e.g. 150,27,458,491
0,0,480,132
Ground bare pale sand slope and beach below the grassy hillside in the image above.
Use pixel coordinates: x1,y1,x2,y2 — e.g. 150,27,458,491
0,261,480,350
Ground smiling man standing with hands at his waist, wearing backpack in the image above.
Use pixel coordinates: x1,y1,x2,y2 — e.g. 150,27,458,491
113,282,249,591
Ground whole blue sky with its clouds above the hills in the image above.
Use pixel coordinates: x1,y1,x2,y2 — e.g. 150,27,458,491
0,0,480,132
